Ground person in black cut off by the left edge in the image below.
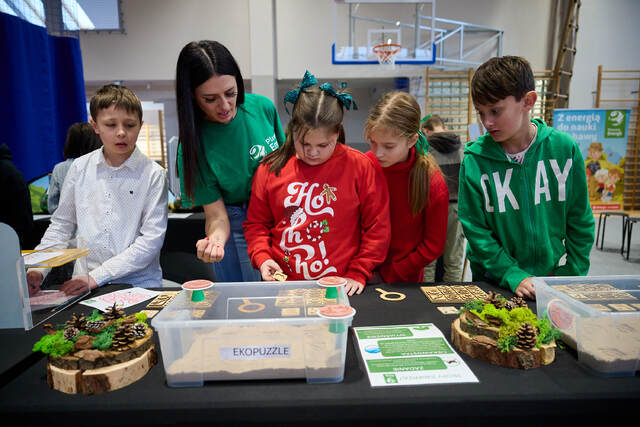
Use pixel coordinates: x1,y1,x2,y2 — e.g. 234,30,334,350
0,144,33,249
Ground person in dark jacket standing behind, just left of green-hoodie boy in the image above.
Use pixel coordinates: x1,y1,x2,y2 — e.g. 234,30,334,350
422,114,464,282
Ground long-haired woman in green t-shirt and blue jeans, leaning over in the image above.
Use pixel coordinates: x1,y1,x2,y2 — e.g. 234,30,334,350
176,40,284,282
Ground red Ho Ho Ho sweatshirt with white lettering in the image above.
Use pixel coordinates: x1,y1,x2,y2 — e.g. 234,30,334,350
243,144,391,284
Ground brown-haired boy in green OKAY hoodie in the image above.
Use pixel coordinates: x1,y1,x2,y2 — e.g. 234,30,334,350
458,56,595,299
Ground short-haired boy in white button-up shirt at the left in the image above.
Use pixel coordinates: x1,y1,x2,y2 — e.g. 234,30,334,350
27,84,167,294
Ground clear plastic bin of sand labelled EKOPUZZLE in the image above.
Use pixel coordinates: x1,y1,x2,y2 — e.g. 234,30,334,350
151,281,351,387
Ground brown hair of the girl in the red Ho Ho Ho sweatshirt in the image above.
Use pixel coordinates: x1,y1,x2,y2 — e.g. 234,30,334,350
263,87,346,176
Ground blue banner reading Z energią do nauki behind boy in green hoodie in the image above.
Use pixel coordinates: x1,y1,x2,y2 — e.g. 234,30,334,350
553,109,631,210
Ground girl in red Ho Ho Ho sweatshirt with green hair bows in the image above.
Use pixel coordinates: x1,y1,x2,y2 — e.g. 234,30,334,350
244,71,390,295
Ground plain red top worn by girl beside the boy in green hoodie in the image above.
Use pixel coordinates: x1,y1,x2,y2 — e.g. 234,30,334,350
367,147,449,283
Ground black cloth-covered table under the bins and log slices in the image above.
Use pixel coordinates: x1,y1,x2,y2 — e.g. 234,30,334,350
0,284,640,426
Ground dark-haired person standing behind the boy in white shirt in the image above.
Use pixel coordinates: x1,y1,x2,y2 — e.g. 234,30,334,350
47,122,102,214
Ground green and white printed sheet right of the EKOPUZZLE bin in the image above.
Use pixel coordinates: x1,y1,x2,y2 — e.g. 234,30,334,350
353,323,478,387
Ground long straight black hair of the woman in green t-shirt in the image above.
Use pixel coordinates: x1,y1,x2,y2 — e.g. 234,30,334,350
176,40,244,198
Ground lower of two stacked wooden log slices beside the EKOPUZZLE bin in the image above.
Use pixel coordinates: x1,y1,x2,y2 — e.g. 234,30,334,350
47,344,157,395
